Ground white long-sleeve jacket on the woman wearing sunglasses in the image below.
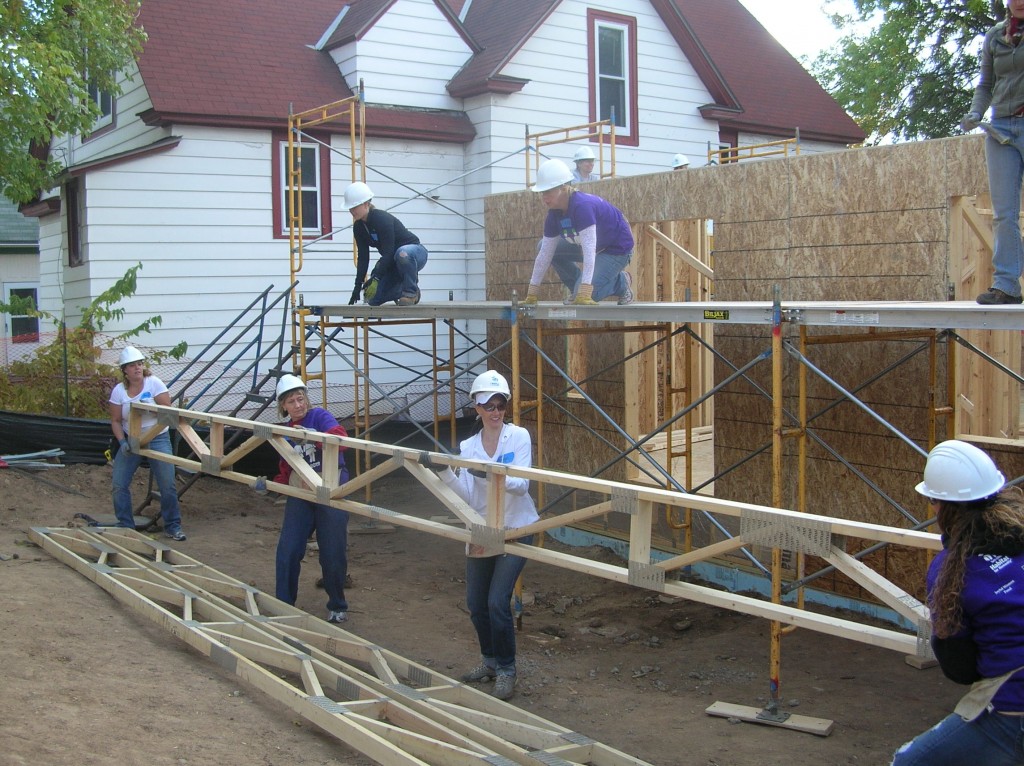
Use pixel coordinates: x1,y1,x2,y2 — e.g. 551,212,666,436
438,423,540,529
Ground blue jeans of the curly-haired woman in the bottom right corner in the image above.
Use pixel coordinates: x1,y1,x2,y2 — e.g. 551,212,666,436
892,713,1024,766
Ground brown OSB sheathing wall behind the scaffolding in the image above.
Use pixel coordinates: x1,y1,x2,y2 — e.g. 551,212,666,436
484,136,1022,593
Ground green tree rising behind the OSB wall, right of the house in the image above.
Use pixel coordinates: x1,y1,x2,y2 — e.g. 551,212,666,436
811,0,1006,142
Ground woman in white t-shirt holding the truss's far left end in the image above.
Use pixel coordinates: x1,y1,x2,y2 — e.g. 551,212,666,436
108,346,185,542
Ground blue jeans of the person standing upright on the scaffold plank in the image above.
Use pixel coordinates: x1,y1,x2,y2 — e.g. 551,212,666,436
985,117,1024,295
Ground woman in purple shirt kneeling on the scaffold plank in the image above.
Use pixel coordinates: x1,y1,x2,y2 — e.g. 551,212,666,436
523,160,633,306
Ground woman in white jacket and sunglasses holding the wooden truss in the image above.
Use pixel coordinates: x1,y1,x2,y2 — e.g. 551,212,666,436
440,370,540,699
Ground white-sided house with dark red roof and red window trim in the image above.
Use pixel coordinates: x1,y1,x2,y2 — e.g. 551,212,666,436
23,0,864,407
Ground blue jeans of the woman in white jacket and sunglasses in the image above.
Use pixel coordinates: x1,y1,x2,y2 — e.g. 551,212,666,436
466,536,534,676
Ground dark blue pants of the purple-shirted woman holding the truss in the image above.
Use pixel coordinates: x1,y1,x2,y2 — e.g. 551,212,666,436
275,498,348,611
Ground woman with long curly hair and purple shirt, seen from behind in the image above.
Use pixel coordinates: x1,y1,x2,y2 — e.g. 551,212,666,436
893,439,1024,766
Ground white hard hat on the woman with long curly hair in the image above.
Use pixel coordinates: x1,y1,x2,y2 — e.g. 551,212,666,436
914,439,1007,503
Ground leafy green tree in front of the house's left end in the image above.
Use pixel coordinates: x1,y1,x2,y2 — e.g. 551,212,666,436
0,0,145,202
